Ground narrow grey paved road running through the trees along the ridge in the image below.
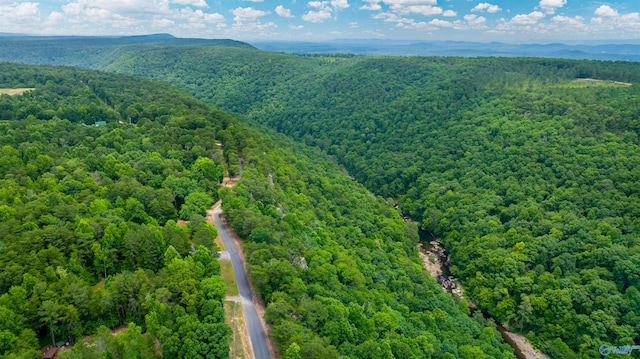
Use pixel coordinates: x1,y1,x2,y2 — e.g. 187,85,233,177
213,205,270,359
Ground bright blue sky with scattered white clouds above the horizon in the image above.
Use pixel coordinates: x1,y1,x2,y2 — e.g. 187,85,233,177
0,0,640,43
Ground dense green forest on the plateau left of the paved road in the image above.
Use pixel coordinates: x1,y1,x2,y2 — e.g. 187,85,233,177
0,64,231,358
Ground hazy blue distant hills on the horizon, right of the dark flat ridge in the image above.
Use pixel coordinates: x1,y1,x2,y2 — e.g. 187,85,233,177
251,40,640,62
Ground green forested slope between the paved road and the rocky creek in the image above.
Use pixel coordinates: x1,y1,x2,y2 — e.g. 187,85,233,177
222,138,514,358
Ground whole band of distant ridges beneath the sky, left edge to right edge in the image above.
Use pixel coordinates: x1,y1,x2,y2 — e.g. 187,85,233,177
0,32,640,62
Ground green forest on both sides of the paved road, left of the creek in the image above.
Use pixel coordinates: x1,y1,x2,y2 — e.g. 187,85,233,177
0,64,514,358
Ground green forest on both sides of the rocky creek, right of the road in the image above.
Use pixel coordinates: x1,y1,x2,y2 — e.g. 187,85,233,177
1,38,640,358
